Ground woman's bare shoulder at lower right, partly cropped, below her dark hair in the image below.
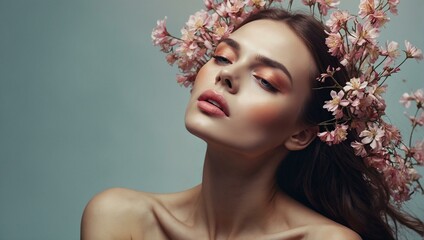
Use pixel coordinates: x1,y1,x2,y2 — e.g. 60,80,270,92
307,224,362,240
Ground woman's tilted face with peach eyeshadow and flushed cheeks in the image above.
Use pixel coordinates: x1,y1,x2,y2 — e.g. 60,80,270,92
186,20,317,158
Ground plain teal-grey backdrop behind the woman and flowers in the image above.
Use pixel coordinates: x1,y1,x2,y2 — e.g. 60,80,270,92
0,0,424,240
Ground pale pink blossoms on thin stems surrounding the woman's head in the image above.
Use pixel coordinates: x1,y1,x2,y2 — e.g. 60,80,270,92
152,0,424,203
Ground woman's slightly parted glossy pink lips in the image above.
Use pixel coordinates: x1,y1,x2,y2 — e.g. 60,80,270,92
197,90,230,117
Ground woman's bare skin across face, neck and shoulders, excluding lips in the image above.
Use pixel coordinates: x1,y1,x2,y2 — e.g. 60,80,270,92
81,20,361,240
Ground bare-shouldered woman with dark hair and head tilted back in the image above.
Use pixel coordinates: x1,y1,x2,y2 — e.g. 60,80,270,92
81,9,424,240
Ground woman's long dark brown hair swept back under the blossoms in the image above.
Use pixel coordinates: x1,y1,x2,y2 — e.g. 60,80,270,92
239,9,424,240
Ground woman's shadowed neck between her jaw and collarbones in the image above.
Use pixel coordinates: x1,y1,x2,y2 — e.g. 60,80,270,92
198,145,284,236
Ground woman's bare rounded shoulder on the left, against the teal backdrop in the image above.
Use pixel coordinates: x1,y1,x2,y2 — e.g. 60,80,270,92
81,188,155,240
